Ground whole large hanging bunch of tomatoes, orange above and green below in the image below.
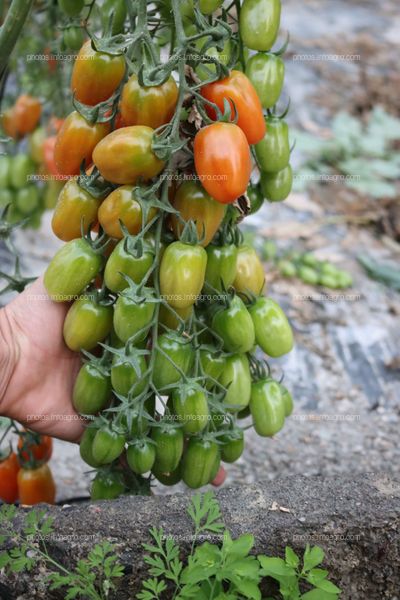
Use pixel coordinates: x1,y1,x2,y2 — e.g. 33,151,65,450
44,0,293,499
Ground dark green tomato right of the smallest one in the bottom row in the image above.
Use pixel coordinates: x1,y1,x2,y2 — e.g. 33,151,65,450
151,417,183,473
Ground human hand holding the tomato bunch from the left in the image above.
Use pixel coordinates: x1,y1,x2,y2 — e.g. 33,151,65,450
0,277,84,442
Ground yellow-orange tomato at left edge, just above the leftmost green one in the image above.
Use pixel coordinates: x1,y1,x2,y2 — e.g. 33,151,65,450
51,179,101,242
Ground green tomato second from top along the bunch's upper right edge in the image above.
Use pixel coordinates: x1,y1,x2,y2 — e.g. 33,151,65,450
246,53,285,108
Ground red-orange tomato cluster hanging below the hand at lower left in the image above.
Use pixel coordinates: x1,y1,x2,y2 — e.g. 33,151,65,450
0,429,56,505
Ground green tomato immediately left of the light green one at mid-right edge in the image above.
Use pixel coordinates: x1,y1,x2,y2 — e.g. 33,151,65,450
212,296,255,353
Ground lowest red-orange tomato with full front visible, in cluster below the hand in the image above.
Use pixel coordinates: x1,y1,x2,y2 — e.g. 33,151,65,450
18,464,56,506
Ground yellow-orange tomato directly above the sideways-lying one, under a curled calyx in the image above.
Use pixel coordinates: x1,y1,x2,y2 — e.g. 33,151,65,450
121,74,178,129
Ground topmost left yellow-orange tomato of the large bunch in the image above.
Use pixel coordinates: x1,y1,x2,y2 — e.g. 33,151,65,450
71,40,125,106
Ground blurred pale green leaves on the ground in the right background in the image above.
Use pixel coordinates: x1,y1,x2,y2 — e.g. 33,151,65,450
294,107,400,198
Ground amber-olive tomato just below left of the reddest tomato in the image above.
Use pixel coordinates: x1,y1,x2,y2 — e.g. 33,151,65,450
171,180,226,246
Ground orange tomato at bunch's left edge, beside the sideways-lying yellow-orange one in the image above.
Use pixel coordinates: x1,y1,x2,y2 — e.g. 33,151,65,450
54,111,110,175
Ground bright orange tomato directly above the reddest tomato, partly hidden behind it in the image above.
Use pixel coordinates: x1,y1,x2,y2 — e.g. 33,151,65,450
201,71,266,144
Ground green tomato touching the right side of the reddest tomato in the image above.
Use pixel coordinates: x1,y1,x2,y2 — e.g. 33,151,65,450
255,117,290,173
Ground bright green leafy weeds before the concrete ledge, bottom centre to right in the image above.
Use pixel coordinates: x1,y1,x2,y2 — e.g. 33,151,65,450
136,493,340,600
